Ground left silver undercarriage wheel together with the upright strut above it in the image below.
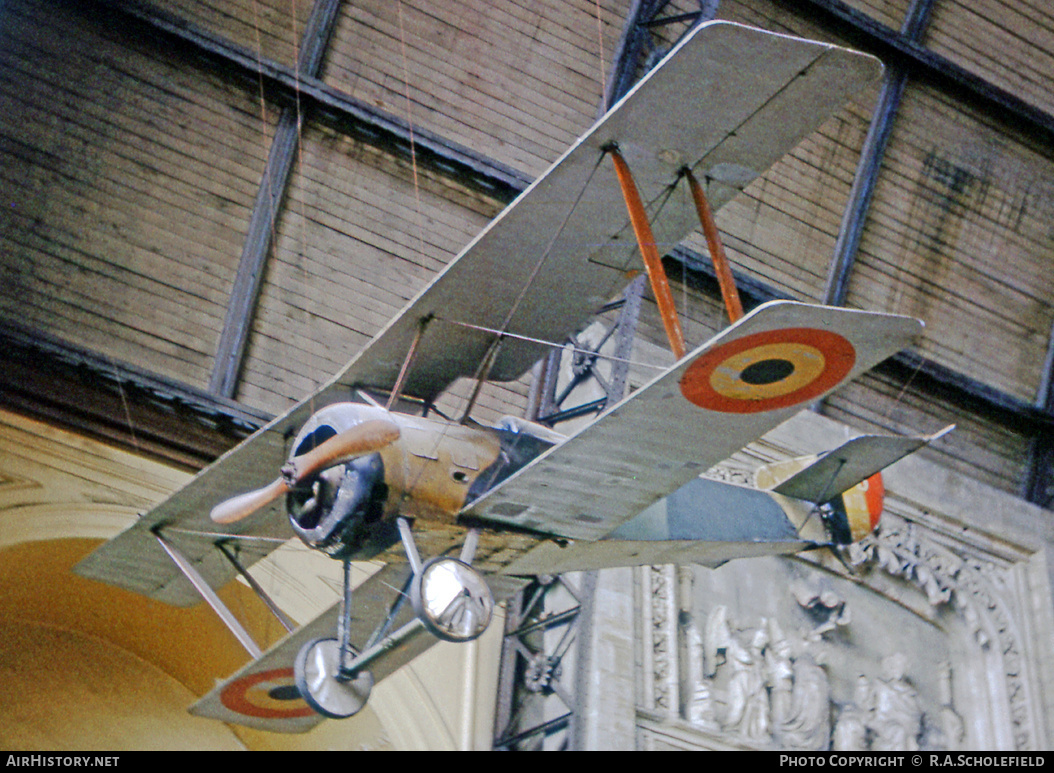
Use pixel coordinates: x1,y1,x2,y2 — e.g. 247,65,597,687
293,560,373,719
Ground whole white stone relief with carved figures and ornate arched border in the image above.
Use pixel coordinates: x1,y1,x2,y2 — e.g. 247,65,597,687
646,517,1034,751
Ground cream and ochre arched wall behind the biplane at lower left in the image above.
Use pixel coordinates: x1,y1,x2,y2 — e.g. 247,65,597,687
0,410,503,751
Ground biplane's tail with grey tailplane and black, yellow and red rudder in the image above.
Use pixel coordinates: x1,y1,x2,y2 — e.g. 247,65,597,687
756,424,955,544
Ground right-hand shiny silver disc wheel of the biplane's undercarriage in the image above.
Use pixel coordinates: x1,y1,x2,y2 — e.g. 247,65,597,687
410,557,494,641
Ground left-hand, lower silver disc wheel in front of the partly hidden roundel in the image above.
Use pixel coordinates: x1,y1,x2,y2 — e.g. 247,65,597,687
293,639,373,719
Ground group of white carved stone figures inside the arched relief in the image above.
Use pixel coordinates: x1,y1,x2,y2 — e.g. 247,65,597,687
666,583,958,751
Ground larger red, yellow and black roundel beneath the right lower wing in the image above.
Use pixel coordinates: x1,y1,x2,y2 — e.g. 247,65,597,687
681,328,856,413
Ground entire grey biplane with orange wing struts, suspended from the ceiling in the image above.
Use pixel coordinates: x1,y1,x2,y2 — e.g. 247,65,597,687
77,22,936,732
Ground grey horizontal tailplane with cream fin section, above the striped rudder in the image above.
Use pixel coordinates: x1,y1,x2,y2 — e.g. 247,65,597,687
757,424,955,503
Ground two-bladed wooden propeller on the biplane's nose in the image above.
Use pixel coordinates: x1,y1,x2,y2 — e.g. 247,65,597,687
209,419,399,523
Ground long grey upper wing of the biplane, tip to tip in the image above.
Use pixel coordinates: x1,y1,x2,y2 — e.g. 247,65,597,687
77,22,881,605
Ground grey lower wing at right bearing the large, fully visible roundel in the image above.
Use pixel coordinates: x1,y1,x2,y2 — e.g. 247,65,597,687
466,302,922,540
